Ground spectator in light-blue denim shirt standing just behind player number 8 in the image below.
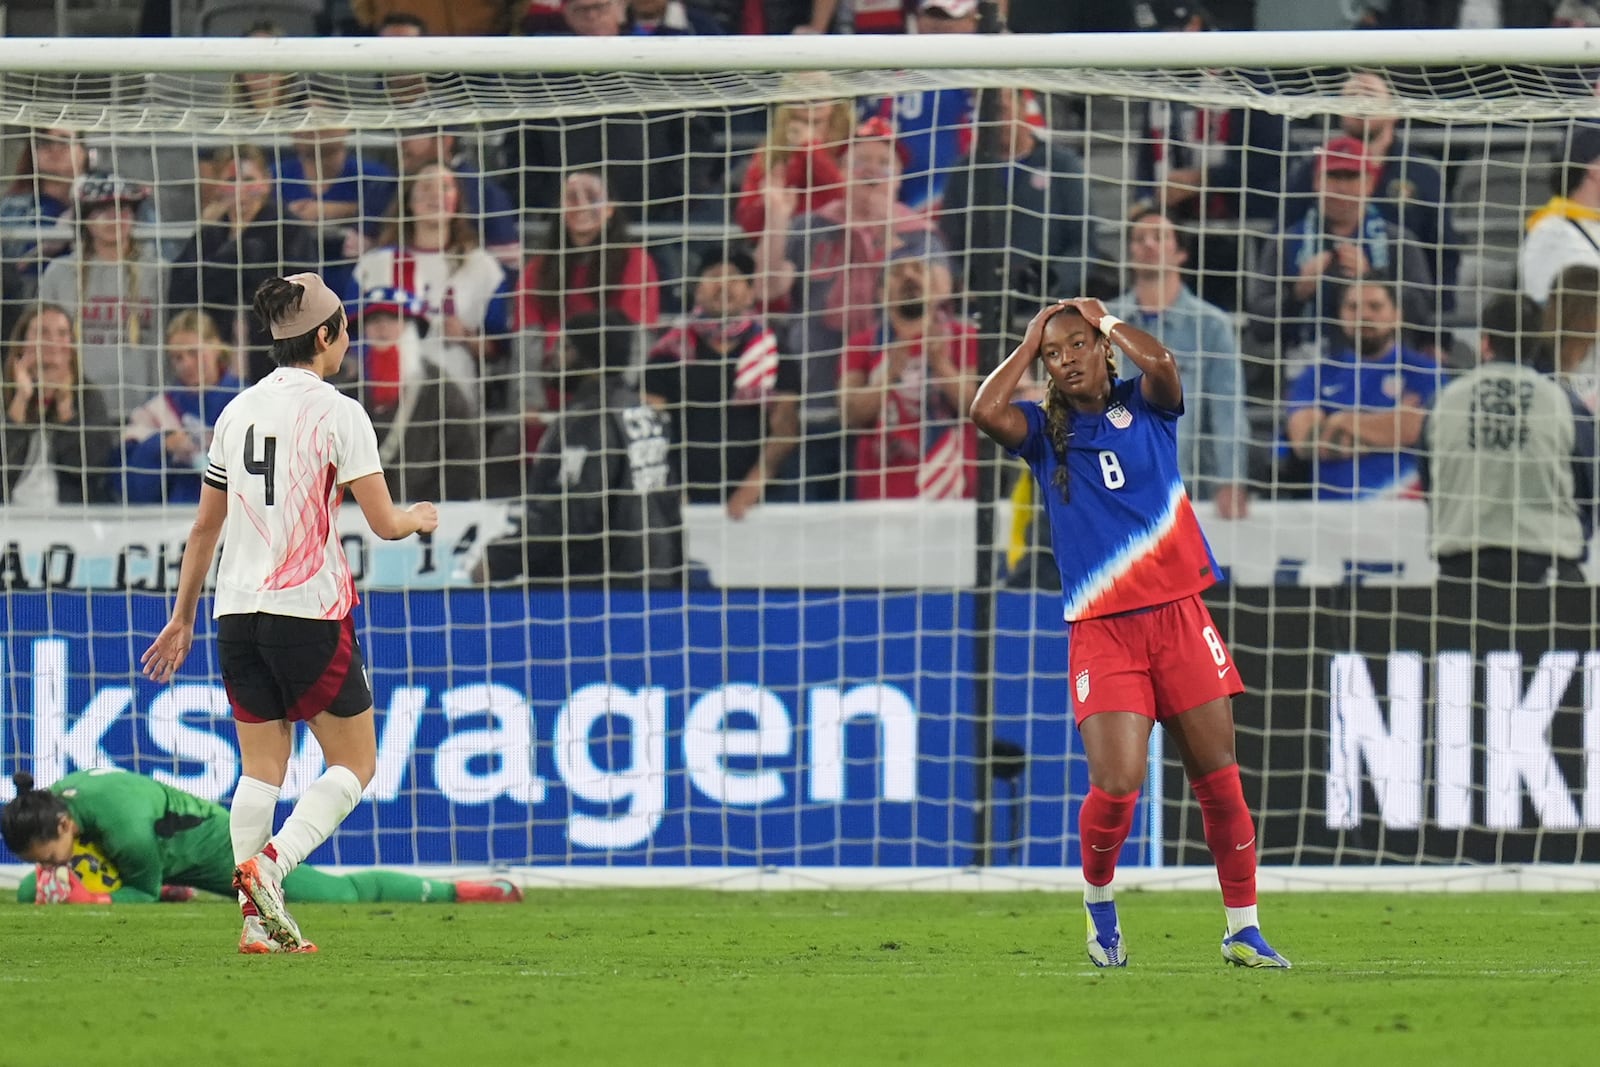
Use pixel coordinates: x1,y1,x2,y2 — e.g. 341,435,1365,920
1107,211,1250,518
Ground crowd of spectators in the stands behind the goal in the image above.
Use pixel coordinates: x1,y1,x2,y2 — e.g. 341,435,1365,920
0,0,1600,585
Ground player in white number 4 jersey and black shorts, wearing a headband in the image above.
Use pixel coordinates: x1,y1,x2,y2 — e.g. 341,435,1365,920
141,274,438,952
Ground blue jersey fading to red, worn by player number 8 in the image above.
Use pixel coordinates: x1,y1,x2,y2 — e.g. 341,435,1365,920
1011,376,1218,622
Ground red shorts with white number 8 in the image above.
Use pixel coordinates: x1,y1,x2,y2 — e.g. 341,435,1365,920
1067,595,1245,723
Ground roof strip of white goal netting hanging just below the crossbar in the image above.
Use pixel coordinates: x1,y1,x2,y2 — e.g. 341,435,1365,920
9,64,1600,134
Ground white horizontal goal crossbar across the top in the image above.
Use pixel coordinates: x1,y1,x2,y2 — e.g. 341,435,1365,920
9,29,1600,74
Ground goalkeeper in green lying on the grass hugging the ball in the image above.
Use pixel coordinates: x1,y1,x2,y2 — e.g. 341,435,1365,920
0,769,522,953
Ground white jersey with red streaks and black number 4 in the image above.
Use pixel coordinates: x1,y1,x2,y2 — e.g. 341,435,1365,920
205,366,382,619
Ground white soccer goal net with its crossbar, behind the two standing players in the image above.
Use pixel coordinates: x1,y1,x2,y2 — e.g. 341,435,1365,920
0,30,1600,885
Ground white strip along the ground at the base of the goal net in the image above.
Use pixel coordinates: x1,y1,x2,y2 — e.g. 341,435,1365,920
0,864,1600,893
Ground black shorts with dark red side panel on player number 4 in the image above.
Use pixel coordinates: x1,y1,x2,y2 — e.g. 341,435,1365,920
216,611,373,723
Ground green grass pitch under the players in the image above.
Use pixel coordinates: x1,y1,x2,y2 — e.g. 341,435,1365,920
0,891,1600,1067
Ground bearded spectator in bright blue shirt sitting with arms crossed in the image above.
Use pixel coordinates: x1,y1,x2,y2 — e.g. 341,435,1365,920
1285,282,1440,501
